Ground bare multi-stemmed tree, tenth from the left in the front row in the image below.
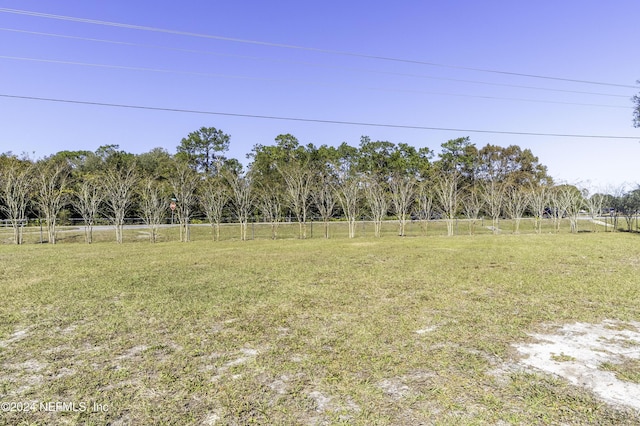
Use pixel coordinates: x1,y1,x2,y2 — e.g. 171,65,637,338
278,163,312,239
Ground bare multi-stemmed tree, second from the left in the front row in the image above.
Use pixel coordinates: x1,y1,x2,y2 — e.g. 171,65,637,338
34,160,71,244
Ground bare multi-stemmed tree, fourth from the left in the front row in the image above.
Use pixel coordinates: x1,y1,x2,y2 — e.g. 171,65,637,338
103,164,138,244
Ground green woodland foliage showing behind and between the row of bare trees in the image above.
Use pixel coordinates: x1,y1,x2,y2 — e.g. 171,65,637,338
0,127,624,235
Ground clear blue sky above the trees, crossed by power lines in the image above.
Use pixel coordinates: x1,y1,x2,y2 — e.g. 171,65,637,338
0,0,640,188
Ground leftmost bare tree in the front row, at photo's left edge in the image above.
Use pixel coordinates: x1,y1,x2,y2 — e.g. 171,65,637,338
0,163,33,244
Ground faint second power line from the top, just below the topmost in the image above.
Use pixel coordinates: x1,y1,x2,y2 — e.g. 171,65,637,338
0,28,629,99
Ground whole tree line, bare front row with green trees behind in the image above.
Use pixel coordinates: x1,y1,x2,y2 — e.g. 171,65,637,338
0,127,640,244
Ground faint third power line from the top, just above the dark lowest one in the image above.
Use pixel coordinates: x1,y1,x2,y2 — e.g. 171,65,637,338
0,55,632,109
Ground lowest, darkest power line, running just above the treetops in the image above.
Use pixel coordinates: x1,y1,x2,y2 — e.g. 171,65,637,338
0,94,638,140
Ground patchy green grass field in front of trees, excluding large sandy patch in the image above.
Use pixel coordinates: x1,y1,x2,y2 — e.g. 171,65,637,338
0,231,640,425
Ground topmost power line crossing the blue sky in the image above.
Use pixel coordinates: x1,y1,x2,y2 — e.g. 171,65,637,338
0,8,638,89
